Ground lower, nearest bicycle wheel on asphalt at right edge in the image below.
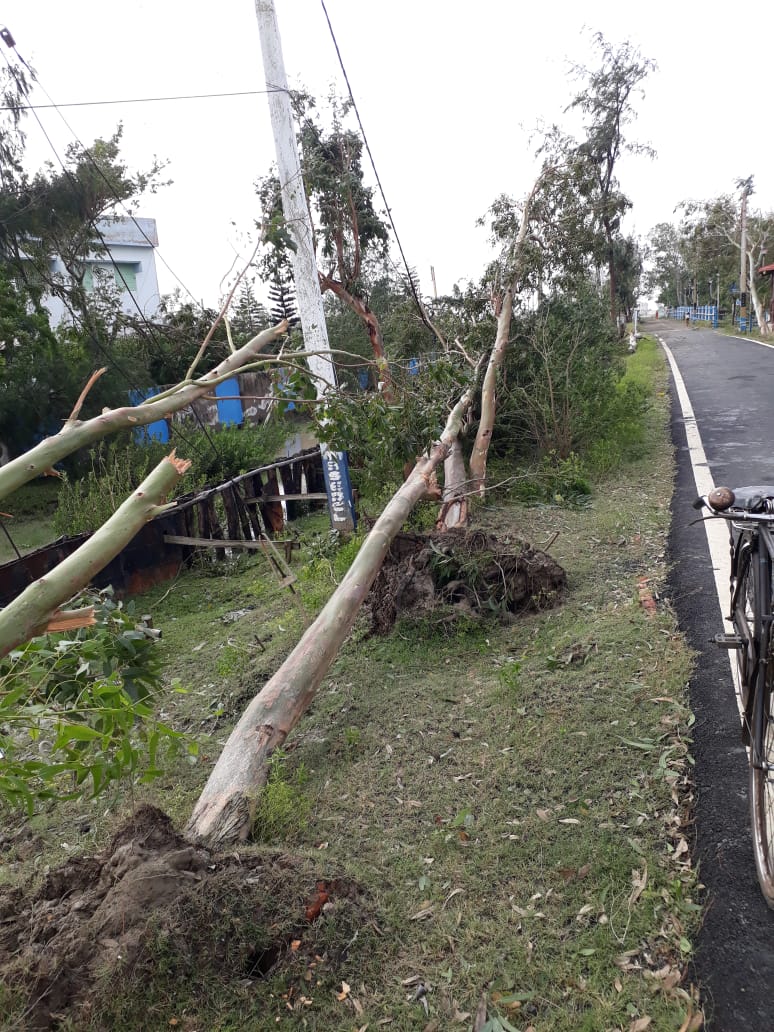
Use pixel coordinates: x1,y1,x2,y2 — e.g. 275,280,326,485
750,667,774,908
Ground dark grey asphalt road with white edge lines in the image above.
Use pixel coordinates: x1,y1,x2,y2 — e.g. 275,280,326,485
648,321,774,1032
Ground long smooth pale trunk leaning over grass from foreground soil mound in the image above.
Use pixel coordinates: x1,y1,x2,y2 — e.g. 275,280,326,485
187,384,475,846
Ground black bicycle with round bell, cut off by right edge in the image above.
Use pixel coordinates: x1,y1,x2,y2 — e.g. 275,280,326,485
694,486,774,908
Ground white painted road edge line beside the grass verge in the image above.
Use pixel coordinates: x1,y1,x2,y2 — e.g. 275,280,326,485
656,336,743,718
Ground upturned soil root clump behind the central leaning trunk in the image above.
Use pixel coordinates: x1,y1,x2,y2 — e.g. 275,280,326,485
368,528,567,635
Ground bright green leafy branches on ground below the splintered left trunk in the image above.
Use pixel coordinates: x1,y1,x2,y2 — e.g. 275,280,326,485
0,592,190,813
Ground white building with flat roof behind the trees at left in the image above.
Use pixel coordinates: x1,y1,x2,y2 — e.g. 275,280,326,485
43,217,160,326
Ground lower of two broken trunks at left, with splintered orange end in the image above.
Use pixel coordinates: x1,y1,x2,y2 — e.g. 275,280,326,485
0,452,191,656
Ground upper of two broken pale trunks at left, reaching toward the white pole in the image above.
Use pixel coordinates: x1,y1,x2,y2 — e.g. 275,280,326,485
0,321,288,498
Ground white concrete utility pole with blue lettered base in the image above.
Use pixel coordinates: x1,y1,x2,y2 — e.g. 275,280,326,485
255,0,355,531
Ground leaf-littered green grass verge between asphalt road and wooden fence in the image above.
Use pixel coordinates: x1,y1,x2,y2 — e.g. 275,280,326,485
0,342,700,1032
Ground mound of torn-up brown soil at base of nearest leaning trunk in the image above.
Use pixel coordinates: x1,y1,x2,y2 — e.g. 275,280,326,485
0,806,362,1030
